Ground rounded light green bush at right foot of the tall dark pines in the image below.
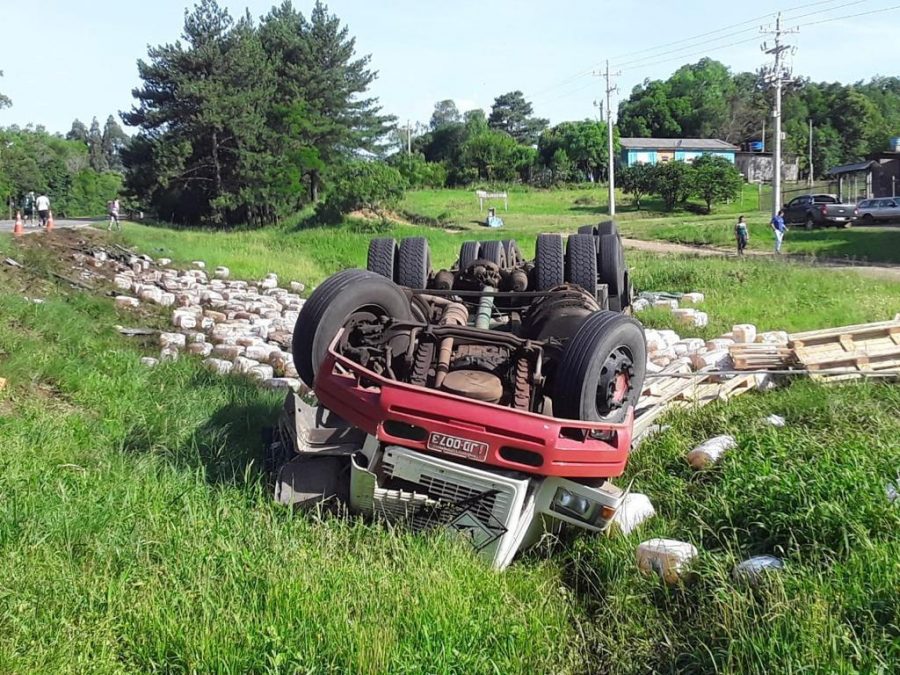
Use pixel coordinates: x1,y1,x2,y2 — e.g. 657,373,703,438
316,160,407,223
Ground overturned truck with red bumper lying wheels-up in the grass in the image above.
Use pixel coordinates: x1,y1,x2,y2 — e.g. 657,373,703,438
273,223,646,568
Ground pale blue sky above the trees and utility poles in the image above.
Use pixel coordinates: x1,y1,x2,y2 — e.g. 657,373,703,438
0,0,900,133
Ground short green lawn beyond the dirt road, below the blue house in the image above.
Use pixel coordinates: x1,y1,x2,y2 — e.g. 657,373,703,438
403,190,900,263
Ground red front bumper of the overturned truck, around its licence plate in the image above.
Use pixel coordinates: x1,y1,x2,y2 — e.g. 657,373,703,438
315,334,634,478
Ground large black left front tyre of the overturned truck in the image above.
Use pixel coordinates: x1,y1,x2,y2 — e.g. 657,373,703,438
291,269,413,387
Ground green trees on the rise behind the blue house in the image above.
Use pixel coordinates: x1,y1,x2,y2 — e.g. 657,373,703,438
618,58,900,177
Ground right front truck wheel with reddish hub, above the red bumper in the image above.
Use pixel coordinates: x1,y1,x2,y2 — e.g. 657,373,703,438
553,311,647,422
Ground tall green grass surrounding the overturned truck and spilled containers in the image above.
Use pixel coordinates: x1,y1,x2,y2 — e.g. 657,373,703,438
0,224,900,673
